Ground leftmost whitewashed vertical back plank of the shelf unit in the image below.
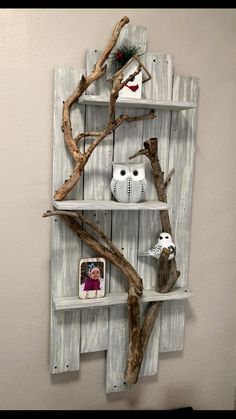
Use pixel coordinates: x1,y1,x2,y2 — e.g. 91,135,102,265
50,66,84,374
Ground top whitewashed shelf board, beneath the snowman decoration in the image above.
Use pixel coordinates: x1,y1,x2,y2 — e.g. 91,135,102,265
78,94,197,111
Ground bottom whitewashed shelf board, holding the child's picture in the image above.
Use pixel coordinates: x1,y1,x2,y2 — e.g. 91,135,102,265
53,288,192,311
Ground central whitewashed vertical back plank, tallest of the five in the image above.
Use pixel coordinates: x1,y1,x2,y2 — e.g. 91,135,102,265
106,25,147,393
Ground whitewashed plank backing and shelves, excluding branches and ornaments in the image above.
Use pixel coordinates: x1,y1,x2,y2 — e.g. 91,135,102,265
50,53,199,393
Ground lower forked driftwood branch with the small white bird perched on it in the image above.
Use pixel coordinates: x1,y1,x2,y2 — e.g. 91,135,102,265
43,139,179,384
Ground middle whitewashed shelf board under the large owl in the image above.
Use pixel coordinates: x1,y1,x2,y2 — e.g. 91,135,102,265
53,199,168,211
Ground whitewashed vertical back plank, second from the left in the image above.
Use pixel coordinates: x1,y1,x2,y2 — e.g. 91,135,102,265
81,50,113,353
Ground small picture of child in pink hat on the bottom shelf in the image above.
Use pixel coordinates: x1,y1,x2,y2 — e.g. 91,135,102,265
79,258,105,299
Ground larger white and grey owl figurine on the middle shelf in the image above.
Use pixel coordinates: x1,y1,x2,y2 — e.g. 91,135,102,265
111,162,147,202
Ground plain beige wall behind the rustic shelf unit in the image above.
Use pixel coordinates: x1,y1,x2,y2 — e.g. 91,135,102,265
0,9,236,410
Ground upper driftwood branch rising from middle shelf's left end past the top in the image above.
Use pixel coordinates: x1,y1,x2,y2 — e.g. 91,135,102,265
54,16,155,201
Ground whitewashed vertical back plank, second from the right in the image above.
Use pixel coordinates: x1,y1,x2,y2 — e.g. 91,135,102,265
138,53,173,376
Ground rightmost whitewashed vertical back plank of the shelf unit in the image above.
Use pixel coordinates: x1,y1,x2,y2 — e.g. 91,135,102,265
160,76,199,352
